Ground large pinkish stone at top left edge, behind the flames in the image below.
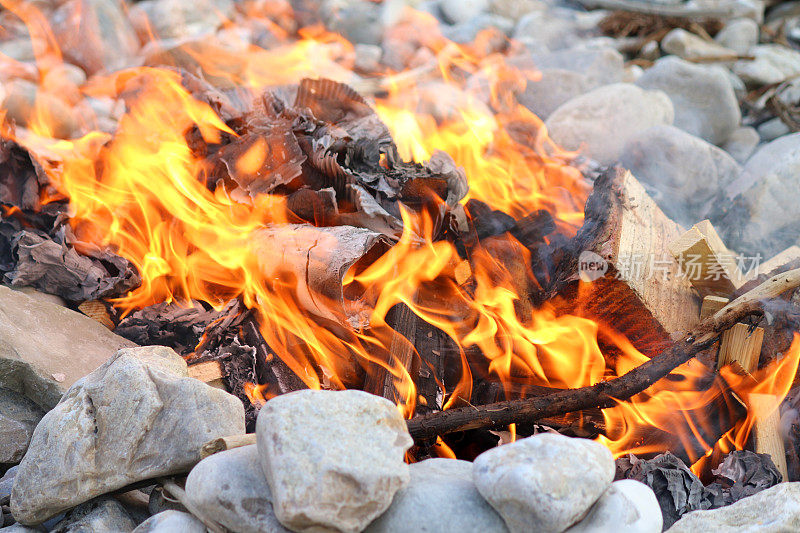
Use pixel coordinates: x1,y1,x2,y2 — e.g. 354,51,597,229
51,0,139,74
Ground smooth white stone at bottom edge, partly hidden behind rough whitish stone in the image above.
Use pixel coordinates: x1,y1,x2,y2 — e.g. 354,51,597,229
567,479,663,533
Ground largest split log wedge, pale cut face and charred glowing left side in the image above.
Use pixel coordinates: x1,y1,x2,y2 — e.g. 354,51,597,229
548,169,700,356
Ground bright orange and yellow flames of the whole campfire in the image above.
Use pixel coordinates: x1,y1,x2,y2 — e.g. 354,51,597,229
0,0,800,465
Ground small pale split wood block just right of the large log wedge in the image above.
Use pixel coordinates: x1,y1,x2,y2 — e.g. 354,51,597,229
669,220,745,296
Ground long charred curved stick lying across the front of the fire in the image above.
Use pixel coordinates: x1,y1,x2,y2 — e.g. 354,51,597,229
408,269,800,441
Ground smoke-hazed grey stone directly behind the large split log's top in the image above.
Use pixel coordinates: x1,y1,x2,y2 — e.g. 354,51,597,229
620,126,741,226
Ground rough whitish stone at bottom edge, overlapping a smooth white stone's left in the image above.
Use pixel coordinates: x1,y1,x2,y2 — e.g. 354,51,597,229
472,433,614,533
